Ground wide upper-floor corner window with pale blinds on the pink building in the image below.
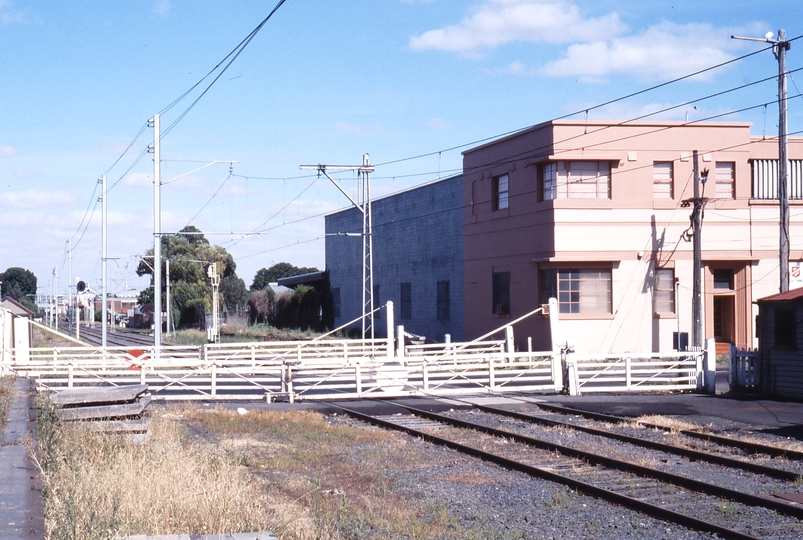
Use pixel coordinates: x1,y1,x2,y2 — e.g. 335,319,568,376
542,161,611,200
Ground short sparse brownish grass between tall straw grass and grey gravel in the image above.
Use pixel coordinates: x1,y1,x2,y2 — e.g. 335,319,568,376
183,410,493,540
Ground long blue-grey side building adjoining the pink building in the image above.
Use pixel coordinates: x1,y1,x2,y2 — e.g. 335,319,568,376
326,176,464,341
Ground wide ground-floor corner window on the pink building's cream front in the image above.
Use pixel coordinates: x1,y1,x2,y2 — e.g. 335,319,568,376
541,268,612,315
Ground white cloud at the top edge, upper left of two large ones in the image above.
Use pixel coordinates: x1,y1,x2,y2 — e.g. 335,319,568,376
410,0,626,55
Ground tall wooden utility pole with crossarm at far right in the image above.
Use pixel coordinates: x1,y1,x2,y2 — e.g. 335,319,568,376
731,30,791,292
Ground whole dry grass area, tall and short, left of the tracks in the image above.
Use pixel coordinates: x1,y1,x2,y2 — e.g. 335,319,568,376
40,407,507,540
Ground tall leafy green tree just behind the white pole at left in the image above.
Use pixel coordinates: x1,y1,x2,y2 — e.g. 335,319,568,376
137,225,248,326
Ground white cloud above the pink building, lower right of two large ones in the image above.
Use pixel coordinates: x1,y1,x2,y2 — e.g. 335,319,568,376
543,22,736,82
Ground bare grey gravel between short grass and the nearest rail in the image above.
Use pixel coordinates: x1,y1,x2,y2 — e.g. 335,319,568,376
332,419,712,540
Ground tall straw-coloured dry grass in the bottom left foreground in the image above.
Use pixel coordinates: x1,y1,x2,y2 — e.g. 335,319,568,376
35,408,312,540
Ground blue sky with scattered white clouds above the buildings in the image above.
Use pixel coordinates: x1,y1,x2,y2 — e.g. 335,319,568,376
0,0,803,294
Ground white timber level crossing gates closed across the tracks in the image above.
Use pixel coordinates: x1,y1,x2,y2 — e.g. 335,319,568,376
0,302,706,402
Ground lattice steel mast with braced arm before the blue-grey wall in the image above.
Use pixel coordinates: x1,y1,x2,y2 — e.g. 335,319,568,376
301,154,376,339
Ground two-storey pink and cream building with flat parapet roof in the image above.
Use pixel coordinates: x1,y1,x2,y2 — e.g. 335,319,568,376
463,120,803,353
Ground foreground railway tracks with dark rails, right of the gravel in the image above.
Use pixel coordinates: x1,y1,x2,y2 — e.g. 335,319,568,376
336,396,803,539
